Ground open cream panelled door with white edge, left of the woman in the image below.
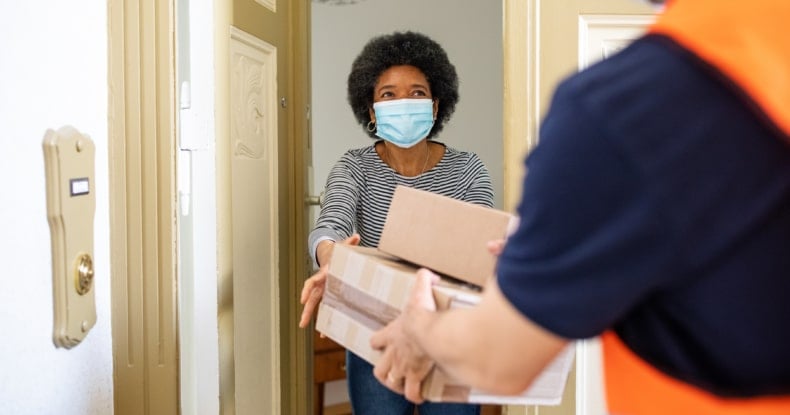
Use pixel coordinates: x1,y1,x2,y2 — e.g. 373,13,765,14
177,0,307,415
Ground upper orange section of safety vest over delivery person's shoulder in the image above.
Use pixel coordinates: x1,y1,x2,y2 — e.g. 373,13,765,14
650,0,790,142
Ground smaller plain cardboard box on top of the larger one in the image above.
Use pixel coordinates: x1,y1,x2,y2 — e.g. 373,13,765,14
379,186,516,286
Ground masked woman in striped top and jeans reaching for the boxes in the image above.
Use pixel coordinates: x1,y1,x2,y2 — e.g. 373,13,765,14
299,32,493,415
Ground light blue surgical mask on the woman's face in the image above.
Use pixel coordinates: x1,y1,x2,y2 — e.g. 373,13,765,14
373,98,433,148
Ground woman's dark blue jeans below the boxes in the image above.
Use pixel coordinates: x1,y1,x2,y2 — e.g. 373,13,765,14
346,351,480,415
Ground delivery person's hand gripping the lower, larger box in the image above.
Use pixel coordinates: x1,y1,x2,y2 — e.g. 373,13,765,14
370,269,439,403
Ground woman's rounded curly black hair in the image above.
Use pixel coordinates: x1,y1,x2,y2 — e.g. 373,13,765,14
348,31,458,138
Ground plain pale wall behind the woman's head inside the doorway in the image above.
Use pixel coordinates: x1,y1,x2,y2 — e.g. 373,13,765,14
311,0,504,208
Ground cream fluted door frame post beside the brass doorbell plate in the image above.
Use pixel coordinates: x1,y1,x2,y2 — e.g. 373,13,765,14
107,0,179,415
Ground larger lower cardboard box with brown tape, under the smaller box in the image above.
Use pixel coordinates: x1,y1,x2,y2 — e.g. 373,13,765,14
316,244,573,405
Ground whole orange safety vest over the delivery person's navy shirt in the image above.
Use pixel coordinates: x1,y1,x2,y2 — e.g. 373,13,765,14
601,0,790,415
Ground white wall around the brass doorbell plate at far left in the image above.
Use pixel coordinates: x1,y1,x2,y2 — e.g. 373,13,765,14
0,0,113,415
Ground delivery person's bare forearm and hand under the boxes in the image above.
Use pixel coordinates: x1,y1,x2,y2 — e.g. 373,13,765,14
371,270,567,402
